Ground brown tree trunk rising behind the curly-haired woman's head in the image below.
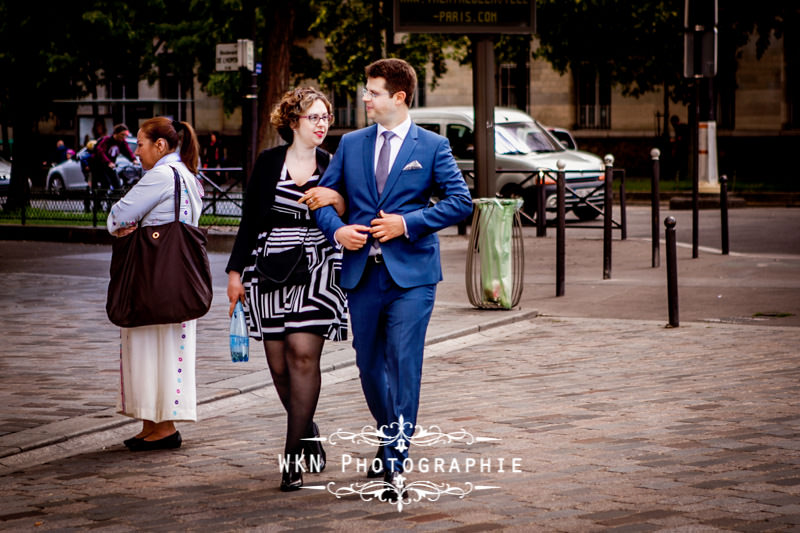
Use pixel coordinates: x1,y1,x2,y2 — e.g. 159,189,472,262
256,2,294,155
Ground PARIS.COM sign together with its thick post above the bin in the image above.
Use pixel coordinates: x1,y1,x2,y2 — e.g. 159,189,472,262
394,0,536,198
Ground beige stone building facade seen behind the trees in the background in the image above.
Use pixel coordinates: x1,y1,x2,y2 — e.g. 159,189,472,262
40,28,800,180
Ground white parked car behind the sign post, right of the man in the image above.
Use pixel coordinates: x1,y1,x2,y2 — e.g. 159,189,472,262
410,106,605,220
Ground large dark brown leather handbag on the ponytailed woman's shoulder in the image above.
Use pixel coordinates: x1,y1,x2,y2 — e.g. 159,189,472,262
106,167,212,328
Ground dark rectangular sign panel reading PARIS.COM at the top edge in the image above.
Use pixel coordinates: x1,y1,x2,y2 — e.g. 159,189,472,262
394,0,536,34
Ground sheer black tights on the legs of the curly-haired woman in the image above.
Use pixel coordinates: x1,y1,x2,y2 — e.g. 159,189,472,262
264,332,325,455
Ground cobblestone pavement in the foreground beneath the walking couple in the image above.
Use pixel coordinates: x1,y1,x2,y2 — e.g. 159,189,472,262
0,318,800,531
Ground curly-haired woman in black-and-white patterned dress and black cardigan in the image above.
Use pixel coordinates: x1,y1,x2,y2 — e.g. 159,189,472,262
226,87,347,491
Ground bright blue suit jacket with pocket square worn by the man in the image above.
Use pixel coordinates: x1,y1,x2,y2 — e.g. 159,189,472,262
315,123,472,289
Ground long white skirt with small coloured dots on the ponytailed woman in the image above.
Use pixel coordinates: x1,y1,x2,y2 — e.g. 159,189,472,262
117,320,197,422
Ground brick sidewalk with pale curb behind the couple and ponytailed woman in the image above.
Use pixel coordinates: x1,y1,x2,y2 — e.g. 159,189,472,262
0,238,536,462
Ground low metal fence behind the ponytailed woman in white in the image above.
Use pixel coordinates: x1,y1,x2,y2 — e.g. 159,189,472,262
0,167,244,227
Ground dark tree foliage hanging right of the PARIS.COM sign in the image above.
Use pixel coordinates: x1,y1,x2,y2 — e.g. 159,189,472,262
535,0,798,102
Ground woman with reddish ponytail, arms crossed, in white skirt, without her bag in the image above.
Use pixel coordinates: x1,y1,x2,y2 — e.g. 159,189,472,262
107,117,202,451
